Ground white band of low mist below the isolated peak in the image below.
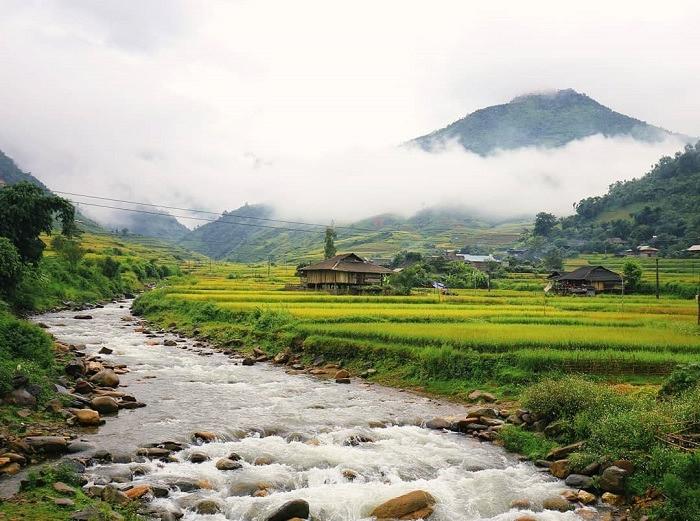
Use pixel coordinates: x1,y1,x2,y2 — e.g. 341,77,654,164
69,135,682,227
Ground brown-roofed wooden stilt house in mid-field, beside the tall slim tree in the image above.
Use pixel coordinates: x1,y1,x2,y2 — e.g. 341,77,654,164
299,253,393,293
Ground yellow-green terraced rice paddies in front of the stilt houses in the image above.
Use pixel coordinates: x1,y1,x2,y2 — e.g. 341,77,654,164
144,259,700,381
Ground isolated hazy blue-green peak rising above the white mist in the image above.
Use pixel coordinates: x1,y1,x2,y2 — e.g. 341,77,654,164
409,89,690,155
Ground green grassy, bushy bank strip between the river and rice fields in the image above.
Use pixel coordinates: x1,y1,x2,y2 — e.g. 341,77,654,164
135,279,700,519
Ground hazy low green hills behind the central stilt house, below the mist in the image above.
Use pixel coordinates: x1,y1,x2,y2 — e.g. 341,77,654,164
180,205,530,262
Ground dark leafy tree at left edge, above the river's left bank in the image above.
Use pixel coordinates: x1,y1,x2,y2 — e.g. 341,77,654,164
0,182,76,264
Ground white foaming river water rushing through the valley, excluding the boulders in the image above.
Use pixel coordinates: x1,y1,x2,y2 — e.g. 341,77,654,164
38,304,592,521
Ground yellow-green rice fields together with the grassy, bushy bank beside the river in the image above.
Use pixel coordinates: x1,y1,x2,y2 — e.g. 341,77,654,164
134,265,700,520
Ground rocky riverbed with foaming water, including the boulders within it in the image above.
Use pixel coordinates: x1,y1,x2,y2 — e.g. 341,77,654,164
1,304,600,521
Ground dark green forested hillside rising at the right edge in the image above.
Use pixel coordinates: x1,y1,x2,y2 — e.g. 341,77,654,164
549,142,700,254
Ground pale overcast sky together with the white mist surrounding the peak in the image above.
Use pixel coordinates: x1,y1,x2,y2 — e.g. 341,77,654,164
0,0,700,220
